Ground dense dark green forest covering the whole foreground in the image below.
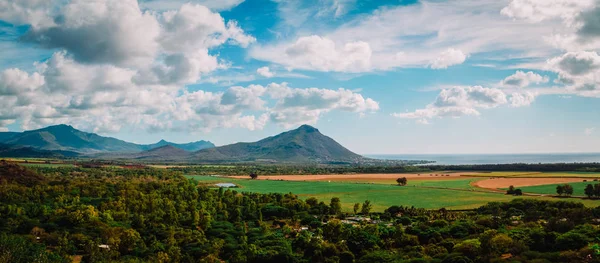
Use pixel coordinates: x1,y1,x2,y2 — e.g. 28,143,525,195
0,163,600,263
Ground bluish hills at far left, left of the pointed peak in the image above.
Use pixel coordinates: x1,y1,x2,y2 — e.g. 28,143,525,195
0,124,214,154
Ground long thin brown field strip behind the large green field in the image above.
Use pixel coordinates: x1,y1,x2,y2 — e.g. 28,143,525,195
228,172,479,182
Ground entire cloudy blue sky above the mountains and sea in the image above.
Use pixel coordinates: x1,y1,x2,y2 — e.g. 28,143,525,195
0,0,600,154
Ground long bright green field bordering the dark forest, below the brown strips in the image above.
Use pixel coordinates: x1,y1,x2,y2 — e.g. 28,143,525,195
187,175,600,211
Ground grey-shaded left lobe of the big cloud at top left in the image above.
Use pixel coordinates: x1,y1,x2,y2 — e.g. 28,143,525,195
25,0,161,66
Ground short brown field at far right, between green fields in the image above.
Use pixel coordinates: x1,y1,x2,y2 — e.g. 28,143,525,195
471,178,581,190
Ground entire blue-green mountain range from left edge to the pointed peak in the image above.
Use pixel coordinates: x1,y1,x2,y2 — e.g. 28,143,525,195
0,125,368,163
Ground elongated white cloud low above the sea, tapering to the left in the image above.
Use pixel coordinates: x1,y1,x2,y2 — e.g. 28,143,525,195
392,86,508,123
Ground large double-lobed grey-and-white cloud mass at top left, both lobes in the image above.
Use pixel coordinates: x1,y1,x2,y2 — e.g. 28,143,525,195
23,0,255,72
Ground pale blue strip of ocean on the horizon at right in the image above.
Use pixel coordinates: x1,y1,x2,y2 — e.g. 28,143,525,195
365,153,600,165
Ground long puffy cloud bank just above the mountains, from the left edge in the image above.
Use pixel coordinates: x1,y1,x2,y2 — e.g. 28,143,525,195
0,49,378,132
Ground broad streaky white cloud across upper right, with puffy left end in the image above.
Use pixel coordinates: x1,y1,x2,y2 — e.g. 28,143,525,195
250,0,576,72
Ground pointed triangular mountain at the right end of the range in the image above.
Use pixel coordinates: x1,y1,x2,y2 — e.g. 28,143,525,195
192,125,366,163
